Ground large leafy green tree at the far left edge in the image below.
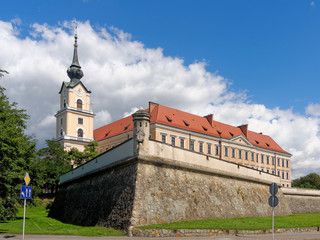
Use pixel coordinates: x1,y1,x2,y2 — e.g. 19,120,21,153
0,74,36,220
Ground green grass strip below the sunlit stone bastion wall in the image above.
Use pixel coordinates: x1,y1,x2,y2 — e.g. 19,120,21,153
140,213,320,230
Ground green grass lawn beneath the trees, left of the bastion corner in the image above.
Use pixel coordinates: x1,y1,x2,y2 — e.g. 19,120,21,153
0,206,125,236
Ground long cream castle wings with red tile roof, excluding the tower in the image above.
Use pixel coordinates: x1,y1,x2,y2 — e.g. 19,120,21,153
93,102,291,187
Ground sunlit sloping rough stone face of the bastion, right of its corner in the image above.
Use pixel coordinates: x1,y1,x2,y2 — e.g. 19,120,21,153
131,158,291,226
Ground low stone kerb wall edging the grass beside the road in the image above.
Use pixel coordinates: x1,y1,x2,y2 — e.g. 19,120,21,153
128,227,319,237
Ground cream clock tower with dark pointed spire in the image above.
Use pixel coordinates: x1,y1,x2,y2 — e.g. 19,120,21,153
55,29,94,151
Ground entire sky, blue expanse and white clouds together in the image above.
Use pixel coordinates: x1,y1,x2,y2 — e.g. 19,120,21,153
0,0,320,178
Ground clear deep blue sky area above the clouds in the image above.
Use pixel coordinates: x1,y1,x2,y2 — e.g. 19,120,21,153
1,0,320,113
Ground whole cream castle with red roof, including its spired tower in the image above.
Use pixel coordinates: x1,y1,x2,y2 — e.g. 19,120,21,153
55,34,291,187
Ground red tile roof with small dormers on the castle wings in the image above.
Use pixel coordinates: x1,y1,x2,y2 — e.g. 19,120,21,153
93,103,290,154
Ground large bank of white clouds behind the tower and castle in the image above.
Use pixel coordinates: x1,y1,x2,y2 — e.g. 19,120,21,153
0,21,320,177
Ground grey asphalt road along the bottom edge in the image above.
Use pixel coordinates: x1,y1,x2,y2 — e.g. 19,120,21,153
0,232,320,240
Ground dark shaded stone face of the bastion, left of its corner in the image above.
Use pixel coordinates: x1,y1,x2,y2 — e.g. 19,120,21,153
49,159,137,229
